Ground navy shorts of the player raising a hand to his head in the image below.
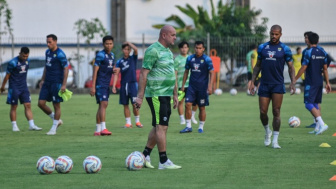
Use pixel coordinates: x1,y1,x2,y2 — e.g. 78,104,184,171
119,82,138,105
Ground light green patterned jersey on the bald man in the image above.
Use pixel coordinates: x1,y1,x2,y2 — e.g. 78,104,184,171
142,42,176,97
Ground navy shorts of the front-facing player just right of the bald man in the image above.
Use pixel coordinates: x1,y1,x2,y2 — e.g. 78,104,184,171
184,86,209,107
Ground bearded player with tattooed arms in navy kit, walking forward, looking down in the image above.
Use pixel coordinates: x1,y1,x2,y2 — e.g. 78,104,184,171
249,25,295,148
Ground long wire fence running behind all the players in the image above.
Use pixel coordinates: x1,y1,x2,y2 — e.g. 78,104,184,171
0,35,336,88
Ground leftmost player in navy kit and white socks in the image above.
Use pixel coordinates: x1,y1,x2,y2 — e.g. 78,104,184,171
0,47,42,132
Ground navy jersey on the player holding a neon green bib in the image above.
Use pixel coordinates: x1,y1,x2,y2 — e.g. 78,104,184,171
45,48,68,83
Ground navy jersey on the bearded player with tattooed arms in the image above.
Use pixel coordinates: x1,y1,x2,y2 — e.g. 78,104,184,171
258,42,293,84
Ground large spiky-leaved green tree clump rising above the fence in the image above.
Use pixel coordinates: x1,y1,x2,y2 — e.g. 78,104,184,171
153,0,268,84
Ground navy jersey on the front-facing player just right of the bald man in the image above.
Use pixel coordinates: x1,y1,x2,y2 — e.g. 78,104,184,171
185,54,214,91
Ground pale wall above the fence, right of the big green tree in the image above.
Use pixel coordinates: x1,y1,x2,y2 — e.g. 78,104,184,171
250,0,336,37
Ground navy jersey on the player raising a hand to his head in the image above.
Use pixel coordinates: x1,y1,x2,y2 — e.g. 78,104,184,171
116,55,138,84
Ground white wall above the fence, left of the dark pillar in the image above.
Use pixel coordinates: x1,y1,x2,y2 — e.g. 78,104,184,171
7,0,111,38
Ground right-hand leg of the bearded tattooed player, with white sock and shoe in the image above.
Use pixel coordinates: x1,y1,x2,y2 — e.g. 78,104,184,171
272,93,283,148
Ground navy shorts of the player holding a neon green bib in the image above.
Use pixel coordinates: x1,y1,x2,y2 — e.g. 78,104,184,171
39,82,63,103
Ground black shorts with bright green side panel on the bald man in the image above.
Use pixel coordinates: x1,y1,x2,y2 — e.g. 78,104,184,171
146,96,171,127
